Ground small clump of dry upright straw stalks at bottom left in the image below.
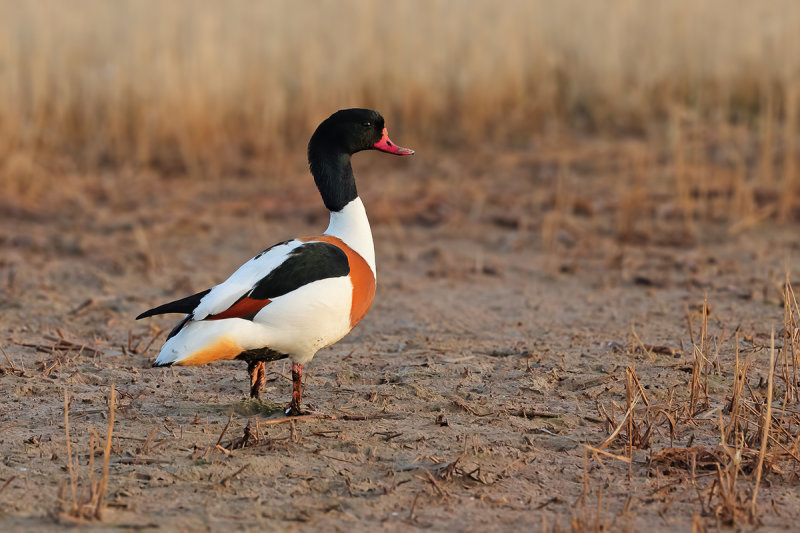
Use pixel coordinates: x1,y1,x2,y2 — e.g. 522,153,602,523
57,384,116,523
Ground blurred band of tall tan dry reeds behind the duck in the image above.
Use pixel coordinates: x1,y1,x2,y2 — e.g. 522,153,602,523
0,0,800,224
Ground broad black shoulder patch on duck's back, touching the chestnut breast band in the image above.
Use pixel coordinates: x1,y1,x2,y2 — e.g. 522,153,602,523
248,242,350,300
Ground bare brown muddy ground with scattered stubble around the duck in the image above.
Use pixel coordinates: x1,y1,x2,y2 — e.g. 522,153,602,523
0,143,800,531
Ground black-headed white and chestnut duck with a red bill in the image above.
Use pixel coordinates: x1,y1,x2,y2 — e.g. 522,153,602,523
136,108,414,416
